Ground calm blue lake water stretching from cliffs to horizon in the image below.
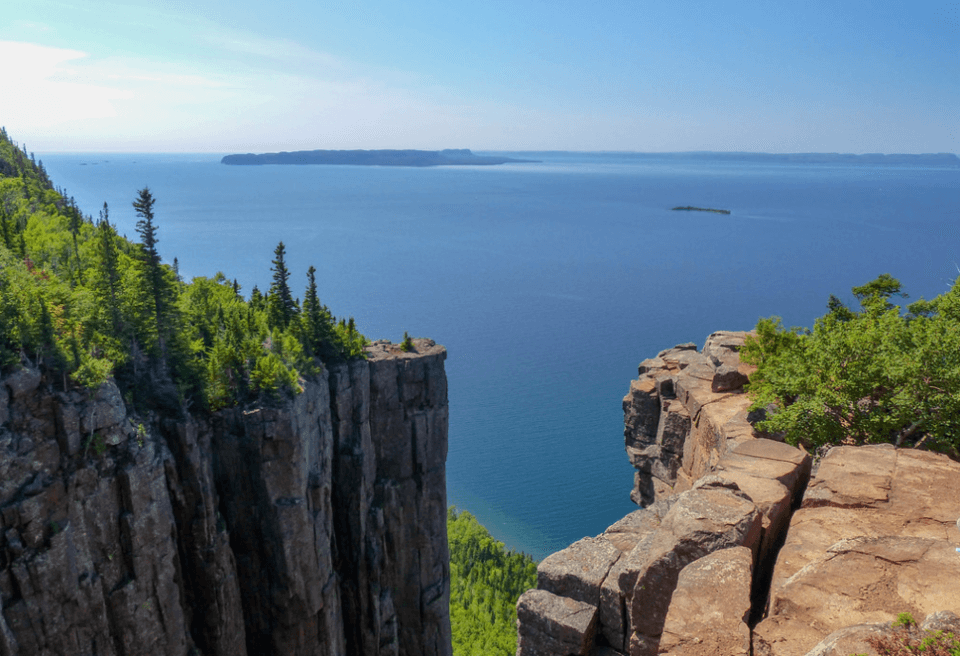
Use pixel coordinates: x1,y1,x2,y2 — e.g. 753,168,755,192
38,153,960,558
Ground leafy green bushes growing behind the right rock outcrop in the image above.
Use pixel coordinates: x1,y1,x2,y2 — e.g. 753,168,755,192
741,274,960,454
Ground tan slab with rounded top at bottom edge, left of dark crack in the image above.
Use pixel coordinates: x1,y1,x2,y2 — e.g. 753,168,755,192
657,547,753,656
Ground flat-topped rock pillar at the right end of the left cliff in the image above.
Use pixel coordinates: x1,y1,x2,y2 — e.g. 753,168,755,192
367,339,451,656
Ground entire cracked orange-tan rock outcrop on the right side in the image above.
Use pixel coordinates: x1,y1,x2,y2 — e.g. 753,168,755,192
517,332,960,656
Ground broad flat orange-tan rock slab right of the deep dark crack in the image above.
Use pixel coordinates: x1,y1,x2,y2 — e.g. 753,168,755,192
754,445,960,656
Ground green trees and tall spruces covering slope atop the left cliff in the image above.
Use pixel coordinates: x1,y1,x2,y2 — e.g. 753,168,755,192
0,129,366,412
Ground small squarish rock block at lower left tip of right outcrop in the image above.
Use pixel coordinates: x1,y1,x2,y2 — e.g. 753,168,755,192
517,590,597,656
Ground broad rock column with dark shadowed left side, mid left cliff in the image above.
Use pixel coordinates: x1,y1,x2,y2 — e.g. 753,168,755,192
211,382,345,656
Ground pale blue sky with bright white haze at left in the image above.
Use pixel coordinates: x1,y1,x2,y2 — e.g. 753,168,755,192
0,0,960,153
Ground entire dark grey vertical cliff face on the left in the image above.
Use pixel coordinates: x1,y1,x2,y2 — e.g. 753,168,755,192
0,340,450,656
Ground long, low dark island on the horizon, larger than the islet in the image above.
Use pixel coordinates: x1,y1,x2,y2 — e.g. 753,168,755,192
220,148,537,166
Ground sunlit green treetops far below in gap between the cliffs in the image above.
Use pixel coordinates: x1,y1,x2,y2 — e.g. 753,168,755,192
447,507,537,656
